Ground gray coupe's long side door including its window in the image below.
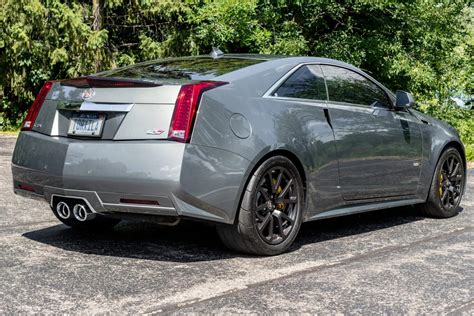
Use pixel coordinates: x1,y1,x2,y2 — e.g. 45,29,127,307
322,65,422,200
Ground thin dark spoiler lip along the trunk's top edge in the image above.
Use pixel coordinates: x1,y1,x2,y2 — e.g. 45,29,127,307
59,76,162,88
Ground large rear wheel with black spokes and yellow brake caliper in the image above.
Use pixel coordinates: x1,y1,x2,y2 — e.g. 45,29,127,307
217,156,304,256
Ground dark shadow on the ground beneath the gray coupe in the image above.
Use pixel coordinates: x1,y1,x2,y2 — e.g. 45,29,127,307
23,207,430,262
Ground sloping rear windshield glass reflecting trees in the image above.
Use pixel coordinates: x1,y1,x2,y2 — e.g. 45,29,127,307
97,57,265,84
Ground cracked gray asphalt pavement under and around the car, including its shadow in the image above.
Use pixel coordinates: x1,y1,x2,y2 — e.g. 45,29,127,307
0,137,474,315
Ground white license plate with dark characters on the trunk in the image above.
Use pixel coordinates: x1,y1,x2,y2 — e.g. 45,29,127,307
68,113,105,137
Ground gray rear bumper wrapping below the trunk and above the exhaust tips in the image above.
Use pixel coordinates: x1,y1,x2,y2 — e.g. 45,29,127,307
12,132,249,223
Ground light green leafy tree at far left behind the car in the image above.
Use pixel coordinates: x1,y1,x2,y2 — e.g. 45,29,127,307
0,0,108,125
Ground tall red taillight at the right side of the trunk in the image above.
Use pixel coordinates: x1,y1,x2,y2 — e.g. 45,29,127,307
168,81,227,142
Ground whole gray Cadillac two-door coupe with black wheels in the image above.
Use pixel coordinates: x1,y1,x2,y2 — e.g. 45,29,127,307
12,54,466,255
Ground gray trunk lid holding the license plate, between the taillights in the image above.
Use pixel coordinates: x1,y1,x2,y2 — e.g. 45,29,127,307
32,80,180,140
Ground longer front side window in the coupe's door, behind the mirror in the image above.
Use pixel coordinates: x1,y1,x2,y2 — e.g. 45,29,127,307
321,66,390,107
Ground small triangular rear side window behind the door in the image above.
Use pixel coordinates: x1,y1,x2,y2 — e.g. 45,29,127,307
273,65,327,101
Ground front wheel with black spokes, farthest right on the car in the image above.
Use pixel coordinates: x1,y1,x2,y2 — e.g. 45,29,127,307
420,147,466,218
